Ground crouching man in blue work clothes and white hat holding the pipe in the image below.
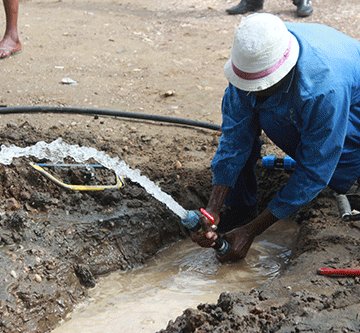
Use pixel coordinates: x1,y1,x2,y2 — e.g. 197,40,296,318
197,13,360,261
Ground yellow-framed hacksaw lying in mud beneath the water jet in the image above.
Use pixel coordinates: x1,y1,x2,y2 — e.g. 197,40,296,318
30,162,125,191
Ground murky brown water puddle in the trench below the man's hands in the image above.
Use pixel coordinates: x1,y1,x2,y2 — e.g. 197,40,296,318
53,221,298,333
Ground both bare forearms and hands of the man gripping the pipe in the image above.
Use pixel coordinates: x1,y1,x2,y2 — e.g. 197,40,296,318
192,185,279,262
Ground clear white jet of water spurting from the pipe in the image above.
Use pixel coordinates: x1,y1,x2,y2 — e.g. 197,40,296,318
0,138,187,219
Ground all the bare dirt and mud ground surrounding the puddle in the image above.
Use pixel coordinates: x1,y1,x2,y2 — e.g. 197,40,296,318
0,0,360,333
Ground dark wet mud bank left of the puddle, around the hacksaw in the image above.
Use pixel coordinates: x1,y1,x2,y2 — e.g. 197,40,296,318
0,125,190,332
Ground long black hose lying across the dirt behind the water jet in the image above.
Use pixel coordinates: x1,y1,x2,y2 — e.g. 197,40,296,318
0,106,221,131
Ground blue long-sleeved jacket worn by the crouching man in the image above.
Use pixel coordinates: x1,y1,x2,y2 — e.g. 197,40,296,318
211,23,360,219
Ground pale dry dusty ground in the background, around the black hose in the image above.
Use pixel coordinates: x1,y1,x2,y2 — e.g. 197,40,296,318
0,0,360,163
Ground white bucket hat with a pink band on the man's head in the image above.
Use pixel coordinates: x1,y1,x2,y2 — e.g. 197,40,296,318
224,13,299,91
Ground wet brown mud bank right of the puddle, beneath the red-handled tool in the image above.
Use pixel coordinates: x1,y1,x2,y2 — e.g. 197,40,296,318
159,190,360,333
